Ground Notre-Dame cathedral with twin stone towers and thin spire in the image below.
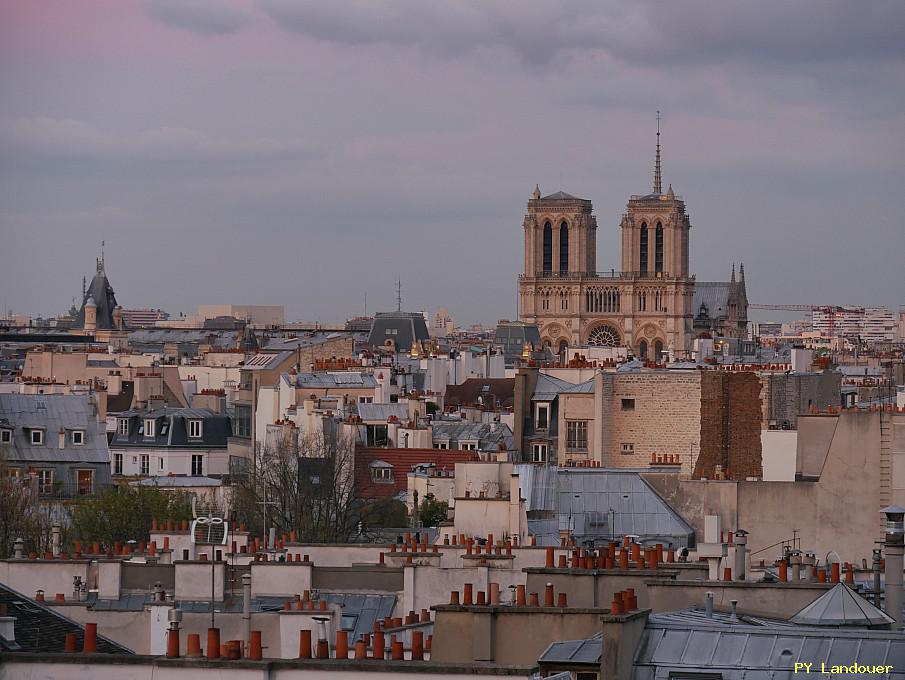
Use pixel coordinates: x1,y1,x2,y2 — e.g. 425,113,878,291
519,131,748,360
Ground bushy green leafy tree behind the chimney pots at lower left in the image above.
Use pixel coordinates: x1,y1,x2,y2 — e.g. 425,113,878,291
72,486,192,544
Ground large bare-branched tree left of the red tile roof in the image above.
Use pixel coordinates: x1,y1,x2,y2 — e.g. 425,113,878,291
233,428,359,543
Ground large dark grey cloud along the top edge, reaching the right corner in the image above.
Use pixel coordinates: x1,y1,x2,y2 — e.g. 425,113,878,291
259,0,905,65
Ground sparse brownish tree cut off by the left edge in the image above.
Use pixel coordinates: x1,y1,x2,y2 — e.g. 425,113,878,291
0,454,53,558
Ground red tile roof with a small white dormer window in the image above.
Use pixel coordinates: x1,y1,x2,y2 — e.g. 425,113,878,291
355,447,477,498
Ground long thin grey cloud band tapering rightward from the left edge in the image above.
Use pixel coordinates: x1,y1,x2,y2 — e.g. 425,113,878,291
0,117,316,167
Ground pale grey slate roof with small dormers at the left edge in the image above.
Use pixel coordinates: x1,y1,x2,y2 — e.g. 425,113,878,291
0,394,110,464
